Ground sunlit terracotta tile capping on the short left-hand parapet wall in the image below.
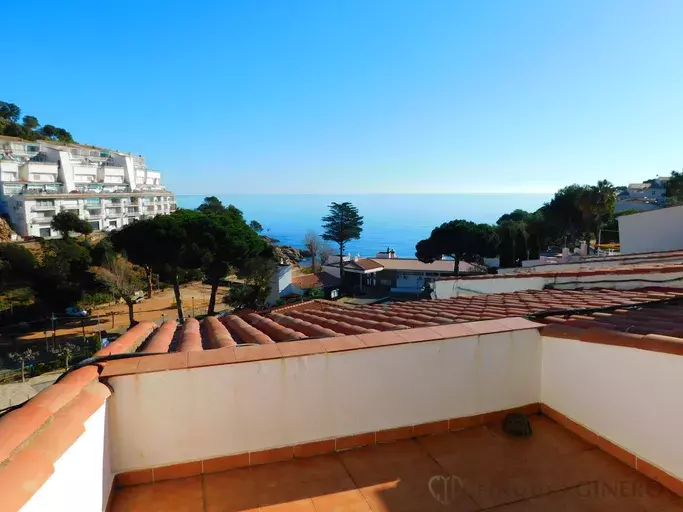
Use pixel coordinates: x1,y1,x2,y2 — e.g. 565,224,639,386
0,372,110,510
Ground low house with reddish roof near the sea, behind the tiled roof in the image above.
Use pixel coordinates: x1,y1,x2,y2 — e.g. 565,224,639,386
323,249,486,294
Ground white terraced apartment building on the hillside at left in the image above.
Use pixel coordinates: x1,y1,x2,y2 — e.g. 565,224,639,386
0,136,176,237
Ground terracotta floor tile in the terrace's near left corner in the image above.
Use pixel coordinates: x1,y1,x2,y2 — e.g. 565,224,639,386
112,476,203,512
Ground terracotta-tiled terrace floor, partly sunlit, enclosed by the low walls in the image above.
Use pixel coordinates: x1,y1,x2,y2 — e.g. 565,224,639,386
112,416,683,512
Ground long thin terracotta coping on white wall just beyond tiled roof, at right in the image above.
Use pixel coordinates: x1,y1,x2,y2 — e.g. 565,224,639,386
444,263,683,281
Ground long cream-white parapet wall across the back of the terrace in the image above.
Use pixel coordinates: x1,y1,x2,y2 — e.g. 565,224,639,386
109,329,541,473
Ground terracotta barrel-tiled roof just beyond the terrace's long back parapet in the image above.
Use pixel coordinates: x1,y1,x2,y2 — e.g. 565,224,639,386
120,288,683,352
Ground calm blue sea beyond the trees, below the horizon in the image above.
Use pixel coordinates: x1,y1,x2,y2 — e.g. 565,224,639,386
176,194,551,258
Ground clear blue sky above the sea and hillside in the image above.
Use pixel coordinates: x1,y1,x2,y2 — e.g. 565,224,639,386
5,0,683,194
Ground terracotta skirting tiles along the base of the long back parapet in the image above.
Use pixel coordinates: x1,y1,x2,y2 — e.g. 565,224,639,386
114,403,541,487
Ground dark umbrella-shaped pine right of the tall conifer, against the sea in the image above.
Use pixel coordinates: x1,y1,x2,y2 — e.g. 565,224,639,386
415,220,498,276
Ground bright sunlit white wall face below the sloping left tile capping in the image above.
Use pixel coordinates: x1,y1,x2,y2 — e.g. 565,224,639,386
21,402,114,512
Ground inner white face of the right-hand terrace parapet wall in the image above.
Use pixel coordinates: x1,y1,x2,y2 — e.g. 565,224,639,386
541,337,683,479
